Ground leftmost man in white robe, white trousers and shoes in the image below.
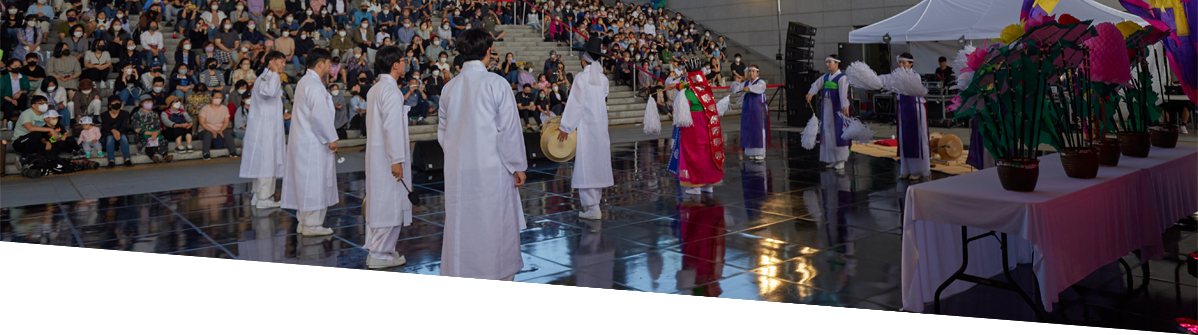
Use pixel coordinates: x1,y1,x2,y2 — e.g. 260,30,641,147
238,51,288,208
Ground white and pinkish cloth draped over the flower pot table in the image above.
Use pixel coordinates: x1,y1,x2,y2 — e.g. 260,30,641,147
902,148,1172,312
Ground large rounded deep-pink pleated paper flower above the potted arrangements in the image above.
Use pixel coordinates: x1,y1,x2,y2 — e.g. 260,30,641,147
1084,23,1131,85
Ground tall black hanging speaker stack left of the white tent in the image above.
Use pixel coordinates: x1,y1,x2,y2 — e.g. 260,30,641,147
785,22,819,127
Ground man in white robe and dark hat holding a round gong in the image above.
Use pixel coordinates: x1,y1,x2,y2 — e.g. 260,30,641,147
557,38,616,220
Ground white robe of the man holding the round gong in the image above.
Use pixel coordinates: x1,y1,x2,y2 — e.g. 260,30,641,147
550,65,616,189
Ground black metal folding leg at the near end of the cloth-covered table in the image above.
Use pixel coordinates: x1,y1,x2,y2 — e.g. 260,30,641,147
932,226,1044,328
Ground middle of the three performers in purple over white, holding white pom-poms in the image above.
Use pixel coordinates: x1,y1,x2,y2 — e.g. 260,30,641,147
807,55,851,170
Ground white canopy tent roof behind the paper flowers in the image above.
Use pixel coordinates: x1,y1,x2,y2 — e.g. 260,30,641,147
848,0,1148,73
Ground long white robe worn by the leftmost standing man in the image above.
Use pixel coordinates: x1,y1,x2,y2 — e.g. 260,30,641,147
238,69,286,179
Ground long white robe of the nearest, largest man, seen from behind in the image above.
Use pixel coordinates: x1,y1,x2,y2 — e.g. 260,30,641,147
437,61,528,285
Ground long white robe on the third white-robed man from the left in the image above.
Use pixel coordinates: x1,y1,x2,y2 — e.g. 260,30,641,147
363,74,412,229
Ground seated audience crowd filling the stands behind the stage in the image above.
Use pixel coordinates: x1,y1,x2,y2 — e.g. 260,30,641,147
0,0,745,172
